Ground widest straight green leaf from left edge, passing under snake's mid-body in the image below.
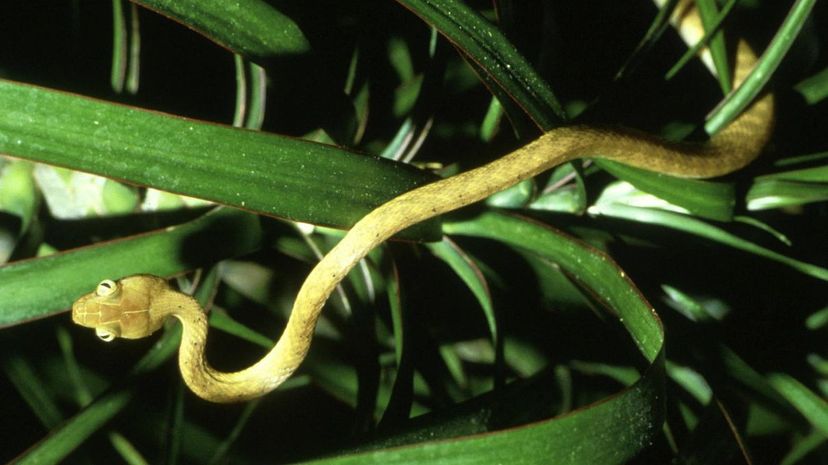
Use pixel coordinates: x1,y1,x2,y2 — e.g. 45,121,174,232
0,81,437,239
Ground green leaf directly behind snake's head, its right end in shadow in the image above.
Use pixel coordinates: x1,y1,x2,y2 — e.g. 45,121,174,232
0,209,260,326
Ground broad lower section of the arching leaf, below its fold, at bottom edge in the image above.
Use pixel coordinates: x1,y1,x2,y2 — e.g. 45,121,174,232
302,358,663,465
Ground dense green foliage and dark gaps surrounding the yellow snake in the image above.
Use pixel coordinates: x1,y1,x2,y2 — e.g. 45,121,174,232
0,0,828,464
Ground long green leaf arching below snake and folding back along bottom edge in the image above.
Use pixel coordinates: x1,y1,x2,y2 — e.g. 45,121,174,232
306,212,665,465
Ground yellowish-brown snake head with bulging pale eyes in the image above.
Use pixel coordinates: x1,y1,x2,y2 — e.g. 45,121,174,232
72,275,167,342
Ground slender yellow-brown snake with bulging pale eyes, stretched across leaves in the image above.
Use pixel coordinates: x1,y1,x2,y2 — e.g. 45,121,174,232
72,1,773,402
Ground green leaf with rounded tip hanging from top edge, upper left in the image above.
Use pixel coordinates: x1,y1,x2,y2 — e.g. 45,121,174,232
136,0,310,58
